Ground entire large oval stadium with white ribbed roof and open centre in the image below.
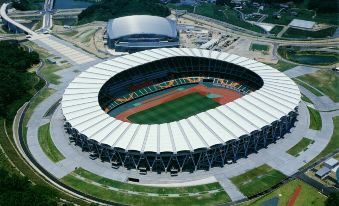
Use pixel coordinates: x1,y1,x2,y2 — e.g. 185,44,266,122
62,48,301,174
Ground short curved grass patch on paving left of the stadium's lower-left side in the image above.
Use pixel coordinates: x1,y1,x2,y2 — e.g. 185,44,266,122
38,123,65,162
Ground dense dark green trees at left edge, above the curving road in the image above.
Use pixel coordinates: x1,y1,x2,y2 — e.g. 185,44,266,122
0,41,39,118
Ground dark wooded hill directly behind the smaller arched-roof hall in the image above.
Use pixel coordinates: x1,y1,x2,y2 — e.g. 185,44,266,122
79,0,170,24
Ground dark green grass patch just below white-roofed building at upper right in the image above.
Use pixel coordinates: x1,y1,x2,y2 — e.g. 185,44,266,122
282,27,336,39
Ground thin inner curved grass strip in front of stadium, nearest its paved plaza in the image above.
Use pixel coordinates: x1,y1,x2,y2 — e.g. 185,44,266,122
73,168,222,194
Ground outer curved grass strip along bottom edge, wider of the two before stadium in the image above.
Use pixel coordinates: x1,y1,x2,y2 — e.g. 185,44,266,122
61,174,230,206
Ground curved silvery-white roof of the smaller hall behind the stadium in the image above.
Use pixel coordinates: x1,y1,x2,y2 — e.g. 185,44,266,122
107,15,177,39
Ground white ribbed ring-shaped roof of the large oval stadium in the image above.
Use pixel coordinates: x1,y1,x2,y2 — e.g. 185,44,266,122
62,48,301,153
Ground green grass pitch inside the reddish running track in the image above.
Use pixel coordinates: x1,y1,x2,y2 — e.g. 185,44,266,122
127,93,220,124
